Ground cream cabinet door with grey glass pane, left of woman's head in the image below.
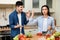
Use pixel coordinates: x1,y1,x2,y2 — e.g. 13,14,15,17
32,0,46,12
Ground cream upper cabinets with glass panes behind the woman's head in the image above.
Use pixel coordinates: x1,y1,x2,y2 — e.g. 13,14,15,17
21,0,55,12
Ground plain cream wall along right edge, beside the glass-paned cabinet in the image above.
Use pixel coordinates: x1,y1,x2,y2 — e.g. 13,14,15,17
54,0,60,26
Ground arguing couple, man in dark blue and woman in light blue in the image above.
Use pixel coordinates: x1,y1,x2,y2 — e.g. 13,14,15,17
9,1,55,40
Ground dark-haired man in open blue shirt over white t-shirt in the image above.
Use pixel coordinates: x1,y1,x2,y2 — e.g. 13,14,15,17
9,1,28,40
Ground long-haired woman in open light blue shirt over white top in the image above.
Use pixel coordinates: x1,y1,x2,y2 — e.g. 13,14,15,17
29,5,55,34
